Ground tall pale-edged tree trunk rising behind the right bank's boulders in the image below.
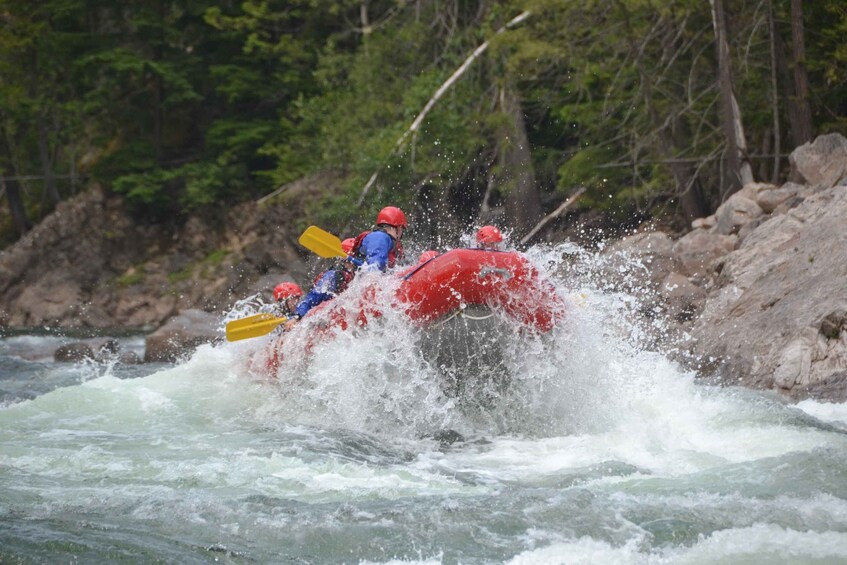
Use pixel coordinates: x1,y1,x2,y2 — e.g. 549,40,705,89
710,0,753,196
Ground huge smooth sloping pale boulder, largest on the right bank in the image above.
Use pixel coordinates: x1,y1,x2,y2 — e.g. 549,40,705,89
691,185,847,392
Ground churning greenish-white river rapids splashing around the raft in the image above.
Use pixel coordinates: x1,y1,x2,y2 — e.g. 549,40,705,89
0,240,847,564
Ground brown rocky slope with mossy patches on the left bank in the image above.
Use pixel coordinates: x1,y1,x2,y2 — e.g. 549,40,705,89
0,176,334,330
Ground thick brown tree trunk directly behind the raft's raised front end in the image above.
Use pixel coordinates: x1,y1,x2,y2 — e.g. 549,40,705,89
498,84,541,237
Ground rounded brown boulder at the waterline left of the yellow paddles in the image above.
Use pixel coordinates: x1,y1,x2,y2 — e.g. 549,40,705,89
144,309,221,362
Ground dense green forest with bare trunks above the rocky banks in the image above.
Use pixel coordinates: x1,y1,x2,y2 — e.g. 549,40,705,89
0,0,847,247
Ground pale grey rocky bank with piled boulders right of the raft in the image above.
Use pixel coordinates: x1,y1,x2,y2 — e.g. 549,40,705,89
609,134,847,400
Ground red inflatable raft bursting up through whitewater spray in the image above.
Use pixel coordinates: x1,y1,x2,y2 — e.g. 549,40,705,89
254,249,564,372
